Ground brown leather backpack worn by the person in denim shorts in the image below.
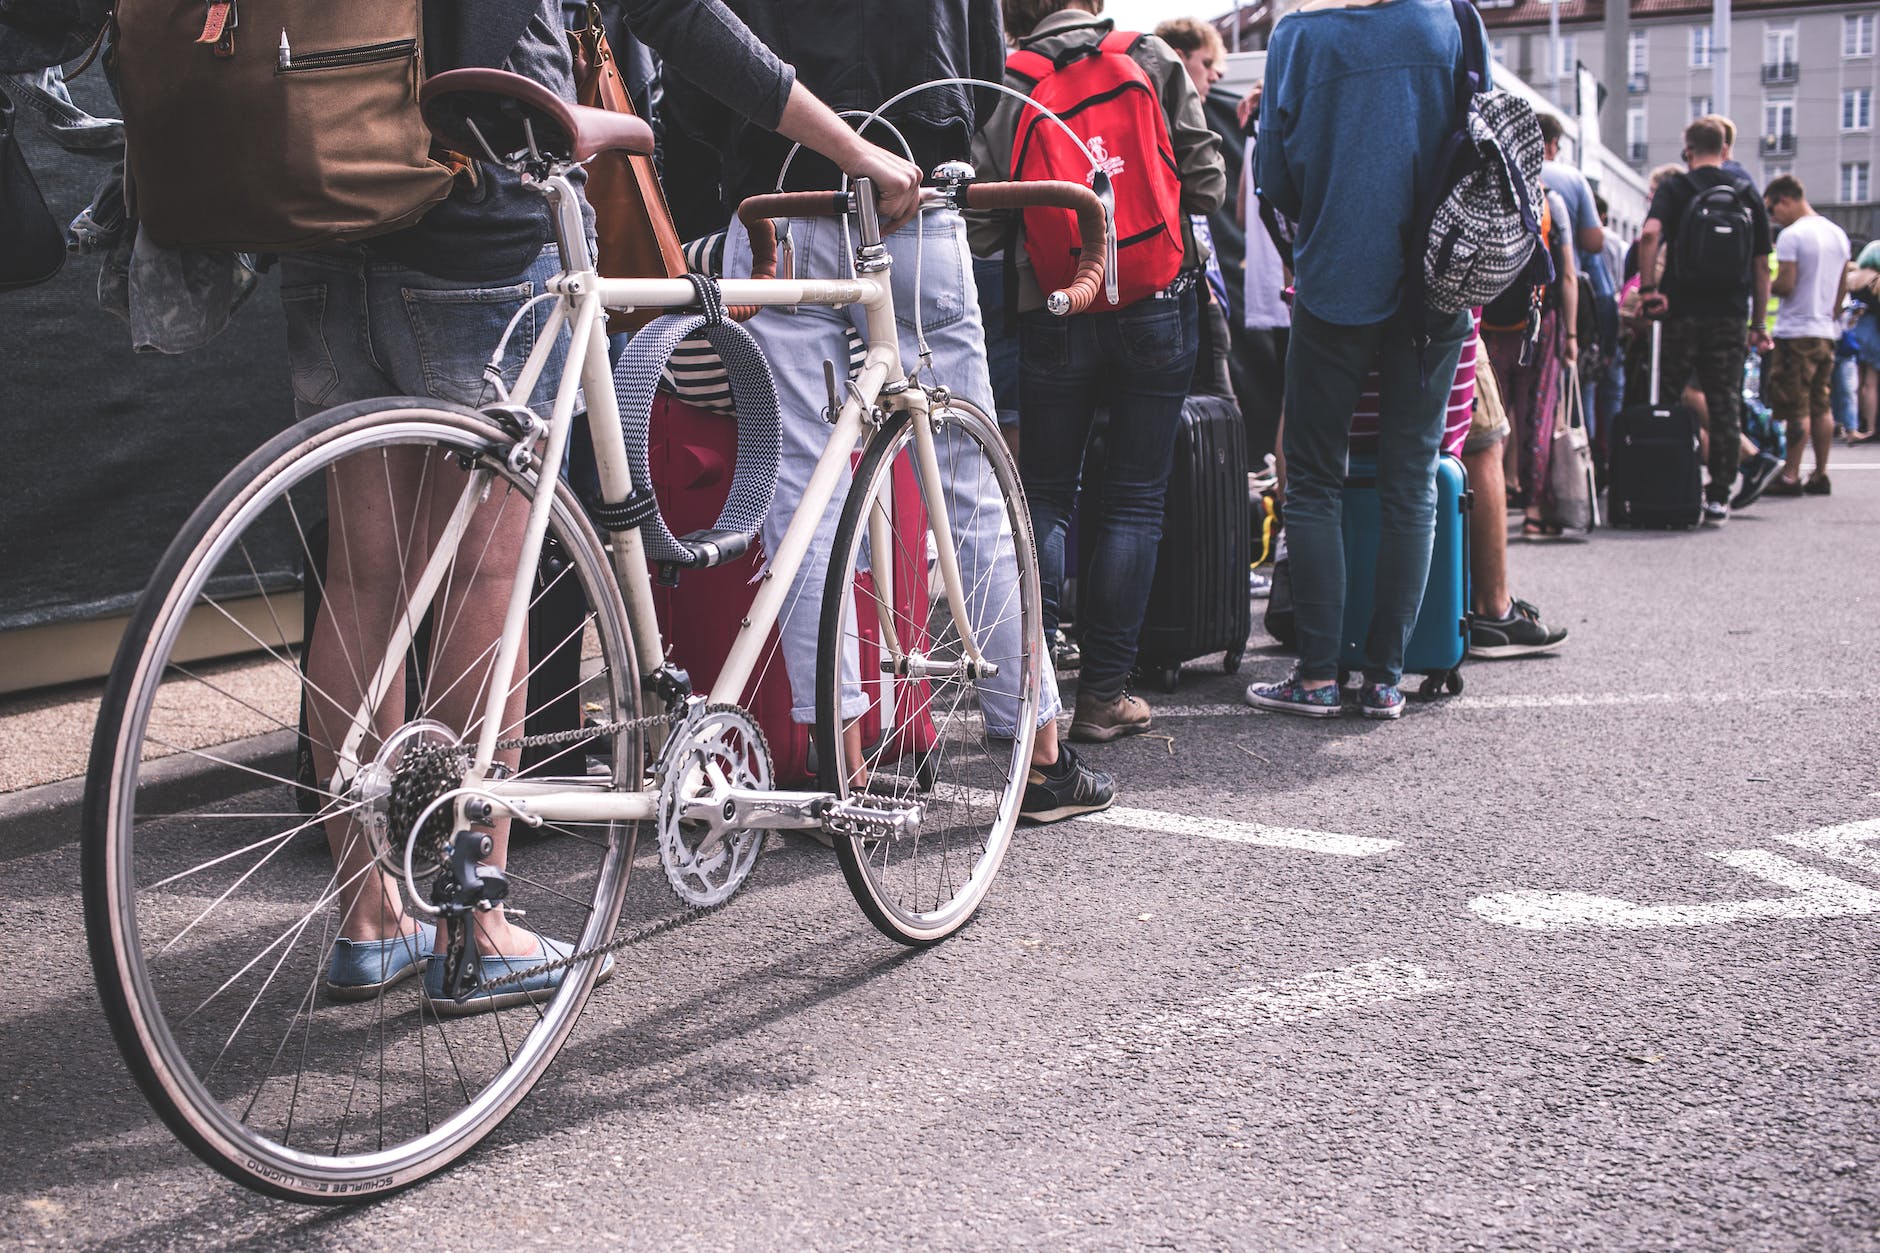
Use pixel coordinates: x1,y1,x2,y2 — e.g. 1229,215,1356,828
113,0,453,252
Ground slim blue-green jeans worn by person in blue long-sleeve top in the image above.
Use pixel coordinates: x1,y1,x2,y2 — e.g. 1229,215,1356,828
1286,305,1493,687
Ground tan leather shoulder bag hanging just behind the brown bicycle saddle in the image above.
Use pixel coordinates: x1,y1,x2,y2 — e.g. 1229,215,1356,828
568,8,686,333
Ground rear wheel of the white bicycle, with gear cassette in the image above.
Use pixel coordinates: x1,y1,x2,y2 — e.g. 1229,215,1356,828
83,401,641,1202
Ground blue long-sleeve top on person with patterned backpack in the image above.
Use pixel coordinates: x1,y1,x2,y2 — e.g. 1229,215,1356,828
1256,0,1489,325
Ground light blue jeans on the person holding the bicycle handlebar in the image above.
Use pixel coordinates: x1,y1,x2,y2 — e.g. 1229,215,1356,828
724,211,1060,736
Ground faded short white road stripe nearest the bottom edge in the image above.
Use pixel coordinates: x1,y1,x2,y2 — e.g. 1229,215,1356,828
1137,958,1449,1046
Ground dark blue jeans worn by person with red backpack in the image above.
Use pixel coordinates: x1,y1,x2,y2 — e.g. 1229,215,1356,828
1019,290,1199,700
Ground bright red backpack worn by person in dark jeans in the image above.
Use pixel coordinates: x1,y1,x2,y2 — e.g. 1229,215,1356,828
1006,30,1183,307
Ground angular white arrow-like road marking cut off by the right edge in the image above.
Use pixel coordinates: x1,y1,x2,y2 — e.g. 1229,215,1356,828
1468,828,1880,931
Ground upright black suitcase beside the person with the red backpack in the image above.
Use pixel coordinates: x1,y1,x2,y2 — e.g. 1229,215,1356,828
1136,395,1254,692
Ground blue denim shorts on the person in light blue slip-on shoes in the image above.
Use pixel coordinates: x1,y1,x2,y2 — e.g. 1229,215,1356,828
280,246,566,418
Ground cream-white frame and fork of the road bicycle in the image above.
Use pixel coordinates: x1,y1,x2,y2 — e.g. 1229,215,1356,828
333,165,983,826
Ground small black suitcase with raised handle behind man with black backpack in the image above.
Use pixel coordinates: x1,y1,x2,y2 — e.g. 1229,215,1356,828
1606,320,1703,529
